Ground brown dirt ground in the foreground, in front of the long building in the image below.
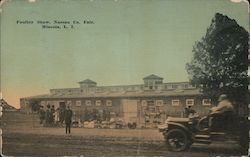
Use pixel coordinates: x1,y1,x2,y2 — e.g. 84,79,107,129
2,111,248,157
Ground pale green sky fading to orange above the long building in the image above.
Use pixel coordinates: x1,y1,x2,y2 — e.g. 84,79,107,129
0,0,248,108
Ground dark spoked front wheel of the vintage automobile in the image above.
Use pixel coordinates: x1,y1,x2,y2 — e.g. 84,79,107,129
166,129,191,152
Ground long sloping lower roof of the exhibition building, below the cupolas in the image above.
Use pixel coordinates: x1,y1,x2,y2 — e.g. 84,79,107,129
22,89,201,99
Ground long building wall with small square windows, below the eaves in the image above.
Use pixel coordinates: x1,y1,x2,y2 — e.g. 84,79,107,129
25,95,212,126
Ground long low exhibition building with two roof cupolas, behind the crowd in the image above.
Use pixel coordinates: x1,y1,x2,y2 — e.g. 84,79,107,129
20,75,211,126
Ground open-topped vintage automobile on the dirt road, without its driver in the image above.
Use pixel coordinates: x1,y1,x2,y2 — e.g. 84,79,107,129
158,115,249,151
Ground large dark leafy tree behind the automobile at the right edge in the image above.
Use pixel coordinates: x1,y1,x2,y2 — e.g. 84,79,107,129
186,13,248,108
